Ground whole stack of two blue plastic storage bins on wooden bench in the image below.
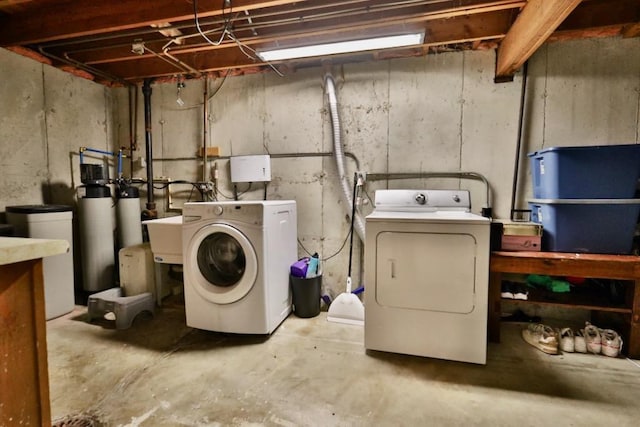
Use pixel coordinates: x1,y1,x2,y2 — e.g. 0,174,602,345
529,144,640,254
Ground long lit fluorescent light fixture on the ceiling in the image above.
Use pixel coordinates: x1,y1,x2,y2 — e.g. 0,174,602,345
257,33,424,61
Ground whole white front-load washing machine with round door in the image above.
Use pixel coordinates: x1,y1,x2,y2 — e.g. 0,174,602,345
182,200,297,334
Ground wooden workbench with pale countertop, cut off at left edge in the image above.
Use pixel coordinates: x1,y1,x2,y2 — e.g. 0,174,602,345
0,237,69,427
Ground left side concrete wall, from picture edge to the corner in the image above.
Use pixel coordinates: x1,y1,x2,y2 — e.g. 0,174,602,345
0,49,114,212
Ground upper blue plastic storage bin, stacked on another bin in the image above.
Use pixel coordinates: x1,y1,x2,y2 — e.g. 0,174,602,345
528,144,640,199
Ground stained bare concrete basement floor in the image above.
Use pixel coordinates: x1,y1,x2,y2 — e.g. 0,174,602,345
47,297,640,426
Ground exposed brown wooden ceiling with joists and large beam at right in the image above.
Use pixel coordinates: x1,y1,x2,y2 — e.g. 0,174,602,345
0,0,640,84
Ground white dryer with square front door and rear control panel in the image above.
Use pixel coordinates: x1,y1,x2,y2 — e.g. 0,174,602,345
365,190,490,364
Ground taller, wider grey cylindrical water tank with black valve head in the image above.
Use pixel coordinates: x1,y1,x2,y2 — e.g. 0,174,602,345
79,185,115,292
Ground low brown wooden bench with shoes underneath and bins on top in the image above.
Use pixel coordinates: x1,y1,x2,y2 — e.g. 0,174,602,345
488,252,640,359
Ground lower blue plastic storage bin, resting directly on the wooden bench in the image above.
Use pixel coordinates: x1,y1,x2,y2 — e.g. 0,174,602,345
529,199,640,254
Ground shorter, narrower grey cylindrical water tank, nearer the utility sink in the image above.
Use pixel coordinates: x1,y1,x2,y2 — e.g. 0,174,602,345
116,186,142,249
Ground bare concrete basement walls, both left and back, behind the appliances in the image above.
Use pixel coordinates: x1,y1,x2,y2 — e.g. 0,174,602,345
0,38,640,292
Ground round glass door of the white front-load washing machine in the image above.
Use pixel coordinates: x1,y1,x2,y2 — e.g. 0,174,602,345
188,223,258,304
